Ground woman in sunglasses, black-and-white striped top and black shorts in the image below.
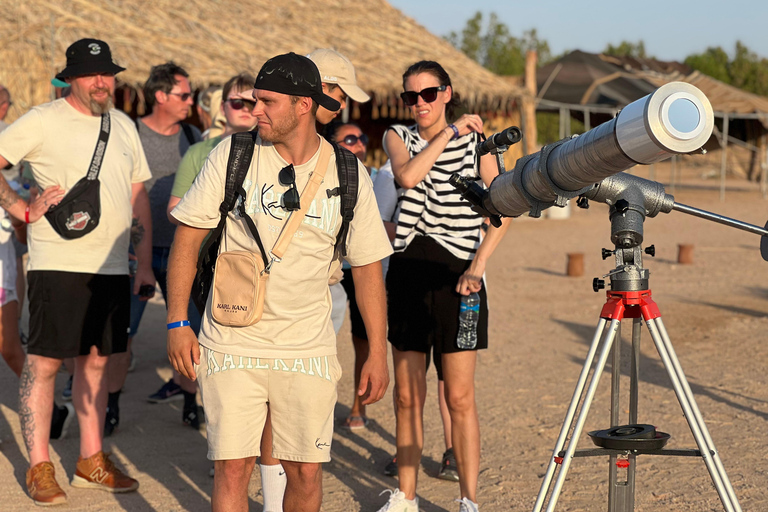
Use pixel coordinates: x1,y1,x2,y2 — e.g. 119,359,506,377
379,61,509,512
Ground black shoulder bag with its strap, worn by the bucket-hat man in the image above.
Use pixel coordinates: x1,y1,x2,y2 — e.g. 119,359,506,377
45,113,110,240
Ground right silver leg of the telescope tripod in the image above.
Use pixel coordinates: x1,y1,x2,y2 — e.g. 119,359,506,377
646,317,741,512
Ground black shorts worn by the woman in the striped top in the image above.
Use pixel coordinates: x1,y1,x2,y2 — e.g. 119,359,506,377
387,236,488,377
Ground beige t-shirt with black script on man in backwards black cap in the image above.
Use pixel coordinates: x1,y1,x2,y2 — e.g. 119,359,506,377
171,138,392,358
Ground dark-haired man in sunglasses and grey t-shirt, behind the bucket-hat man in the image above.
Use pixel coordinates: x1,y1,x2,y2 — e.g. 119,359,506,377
104,62,202,436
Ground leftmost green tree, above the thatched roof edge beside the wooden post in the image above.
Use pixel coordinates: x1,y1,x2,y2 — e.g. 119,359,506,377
446,11,551,75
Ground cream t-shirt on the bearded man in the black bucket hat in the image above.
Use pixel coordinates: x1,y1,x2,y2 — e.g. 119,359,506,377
0,98,151,275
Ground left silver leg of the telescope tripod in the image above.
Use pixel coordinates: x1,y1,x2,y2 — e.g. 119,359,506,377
533,318,621,512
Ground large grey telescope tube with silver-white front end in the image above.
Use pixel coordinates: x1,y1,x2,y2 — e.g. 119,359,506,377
484,82,714,217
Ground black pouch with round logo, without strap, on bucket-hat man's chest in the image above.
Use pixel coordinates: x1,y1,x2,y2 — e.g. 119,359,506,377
45,178,101,240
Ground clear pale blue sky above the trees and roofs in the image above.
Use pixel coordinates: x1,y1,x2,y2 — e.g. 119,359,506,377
388,0,768,61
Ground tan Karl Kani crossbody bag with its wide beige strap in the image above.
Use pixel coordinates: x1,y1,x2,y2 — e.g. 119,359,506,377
211,139,333,327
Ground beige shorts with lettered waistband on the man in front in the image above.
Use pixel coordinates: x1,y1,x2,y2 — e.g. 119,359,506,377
195,346,341,462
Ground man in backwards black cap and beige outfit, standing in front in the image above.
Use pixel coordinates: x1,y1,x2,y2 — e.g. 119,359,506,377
168,53,392,512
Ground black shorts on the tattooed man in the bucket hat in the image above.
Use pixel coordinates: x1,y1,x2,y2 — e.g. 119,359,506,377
28,270,131,359
